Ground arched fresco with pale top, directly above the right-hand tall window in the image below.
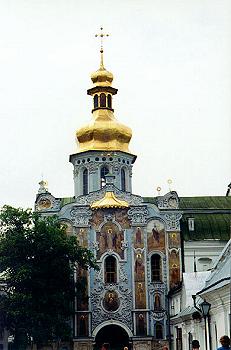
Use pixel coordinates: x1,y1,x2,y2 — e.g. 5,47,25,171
147,220,165,252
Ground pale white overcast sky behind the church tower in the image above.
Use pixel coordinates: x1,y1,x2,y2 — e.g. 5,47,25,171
0,0,231,207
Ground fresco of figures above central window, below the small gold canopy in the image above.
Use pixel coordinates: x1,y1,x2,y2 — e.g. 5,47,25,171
96,221,124,259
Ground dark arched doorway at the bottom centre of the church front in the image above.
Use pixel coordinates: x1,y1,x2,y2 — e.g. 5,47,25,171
94,325,129,350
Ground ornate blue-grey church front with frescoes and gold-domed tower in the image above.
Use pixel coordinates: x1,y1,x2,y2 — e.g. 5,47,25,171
35,49,182,350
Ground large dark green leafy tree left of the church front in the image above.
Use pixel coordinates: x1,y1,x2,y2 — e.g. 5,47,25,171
0,206,96,350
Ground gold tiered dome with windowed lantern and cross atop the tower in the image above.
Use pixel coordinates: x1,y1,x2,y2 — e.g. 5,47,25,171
76,28,132,153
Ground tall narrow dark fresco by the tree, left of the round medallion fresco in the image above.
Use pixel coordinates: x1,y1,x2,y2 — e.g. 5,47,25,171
77,268,88,311
